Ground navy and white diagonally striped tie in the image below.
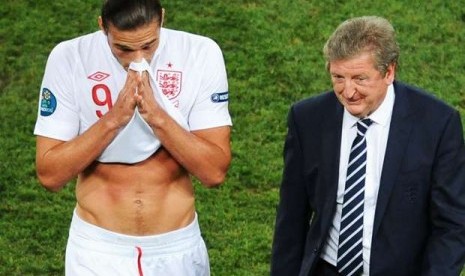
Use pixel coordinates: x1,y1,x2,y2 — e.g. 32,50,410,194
337,119,373,276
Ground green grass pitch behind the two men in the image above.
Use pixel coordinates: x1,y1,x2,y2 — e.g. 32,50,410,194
0,0,465,275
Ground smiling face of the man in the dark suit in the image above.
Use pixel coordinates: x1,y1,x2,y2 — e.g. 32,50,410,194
329,52,395,118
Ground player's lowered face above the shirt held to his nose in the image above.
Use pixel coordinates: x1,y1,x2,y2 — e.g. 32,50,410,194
101,20,161,70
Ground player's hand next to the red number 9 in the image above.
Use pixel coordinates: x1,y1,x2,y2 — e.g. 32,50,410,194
107,70,140,127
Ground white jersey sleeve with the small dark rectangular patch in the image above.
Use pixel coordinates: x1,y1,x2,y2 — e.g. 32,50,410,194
189,39,232,130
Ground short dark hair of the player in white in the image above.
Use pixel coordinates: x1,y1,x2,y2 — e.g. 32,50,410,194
101,0,162,31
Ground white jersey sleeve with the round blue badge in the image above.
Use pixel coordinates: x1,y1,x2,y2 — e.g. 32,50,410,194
34,42,79,141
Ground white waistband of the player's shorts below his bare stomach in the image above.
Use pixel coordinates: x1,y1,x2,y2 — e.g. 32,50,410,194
68,210,202,255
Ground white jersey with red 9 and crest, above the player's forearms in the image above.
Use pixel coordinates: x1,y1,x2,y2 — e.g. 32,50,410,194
34,28,232,144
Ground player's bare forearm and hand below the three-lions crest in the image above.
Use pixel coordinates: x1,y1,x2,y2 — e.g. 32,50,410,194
129,72,231,187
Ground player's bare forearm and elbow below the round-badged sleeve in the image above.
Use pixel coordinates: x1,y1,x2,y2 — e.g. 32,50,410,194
36,117,118,191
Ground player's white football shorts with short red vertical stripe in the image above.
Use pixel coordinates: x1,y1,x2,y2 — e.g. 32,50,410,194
65,211,210,276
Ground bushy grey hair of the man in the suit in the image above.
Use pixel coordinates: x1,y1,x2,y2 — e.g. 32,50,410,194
323,16,400,74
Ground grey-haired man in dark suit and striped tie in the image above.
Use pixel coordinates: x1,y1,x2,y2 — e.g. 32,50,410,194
271,16,465,276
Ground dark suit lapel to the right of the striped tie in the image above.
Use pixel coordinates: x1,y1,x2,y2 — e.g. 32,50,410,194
373,82,413,236
